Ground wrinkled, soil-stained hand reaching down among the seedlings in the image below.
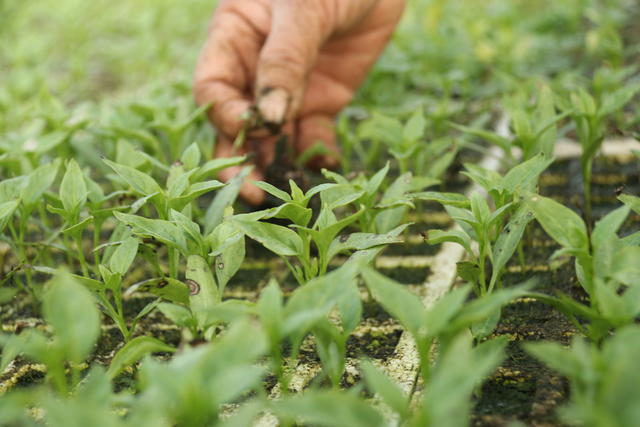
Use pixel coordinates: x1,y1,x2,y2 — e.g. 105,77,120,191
194,0,404,205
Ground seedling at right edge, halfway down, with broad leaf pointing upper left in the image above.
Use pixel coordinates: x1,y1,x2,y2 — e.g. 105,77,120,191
525,195,640,342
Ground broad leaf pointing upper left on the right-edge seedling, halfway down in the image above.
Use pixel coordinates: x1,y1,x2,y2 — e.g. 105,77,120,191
524,194,589,251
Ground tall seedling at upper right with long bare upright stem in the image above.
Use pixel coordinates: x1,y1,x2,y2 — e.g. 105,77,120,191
563,83,640,230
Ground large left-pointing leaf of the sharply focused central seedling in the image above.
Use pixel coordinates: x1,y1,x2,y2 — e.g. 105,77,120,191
234,220,303,256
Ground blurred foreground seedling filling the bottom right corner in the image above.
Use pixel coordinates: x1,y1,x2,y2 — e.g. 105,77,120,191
525,326,640,426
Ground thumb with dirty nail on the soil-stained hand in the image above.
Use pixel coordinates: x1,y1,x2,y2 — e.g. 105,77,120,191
255,0,333,125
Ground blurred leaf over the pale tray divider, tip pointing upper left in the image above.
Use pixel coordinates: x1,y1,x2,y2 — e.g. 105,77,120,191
362,267,425,339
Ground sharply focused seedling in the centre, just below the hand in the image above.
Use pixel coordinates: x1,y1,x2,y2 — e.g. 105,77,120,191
222,180,408,285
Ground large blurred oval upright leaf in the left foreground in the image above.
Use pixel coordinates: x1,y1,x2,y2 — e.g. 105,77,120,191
42,273,100,364
